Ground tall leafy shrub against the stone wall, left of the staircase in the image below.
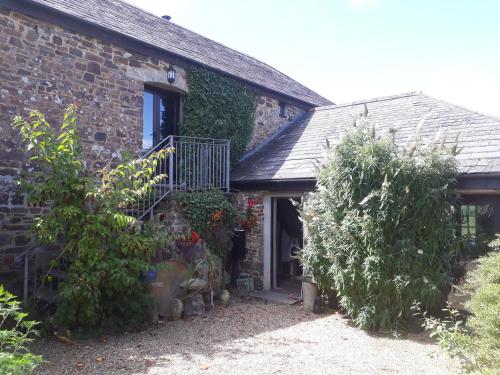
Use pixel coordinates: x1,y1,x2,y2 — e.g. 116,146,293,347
14,107,170,328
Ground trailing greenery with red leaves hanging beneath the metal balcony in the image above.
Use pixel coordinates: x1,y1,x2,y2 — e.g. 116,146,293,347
174,190,237,260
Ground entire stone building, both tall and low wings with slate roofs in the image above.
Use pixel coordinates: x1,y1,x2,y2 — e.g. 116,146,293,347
0,0,500,296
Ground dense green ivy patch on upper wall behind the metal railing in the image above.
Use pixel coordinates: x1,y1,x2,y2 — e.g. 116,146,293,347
181,66,255,164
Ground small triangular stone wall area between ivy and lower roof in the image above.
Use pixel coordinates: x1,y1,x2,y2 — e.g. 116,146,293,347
247,96,304,150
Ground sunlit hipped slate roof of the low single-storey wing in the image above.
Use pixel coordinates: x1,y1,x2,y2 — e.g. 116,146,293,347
231,93,500,182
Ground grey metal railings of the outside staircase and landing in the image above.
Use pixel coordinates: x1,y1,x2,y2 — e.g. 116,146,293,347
135,135,231,220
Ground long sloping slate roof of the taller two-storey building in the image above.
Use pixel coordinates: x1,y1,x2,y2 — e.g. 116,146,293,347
29,0,332,106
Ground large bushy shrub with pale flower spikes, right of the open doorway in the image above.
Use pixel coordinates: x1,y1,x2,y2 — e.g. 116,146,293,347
302,114,457,329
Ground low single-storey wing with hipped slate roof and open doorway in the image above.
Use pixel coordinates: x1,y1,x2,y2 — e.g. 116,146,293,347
231,92,500,288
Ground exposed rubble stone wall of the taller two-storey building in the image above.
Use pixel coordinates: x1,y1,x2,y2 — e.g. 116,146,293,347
0,7,301,269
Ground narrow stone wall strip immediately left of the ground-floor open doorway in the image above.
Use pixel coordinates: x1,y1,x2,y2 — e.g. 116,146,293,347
234,192,264,274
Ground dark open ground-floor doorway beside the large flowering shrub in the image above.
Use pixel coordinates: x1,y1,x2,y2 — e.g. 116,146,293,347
271,197,304,297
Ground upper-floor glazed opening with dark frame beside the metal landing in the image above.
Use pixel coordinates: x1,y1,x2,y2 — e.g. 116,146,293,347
142,87,180,150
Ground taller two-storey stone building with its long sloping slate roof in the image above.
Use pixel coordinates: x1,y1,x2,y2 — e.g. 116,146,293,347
0,0,331,284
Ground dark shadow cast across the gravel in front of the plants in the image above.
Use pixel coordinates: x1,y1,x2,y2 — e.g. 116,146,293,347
33,297,325,375
